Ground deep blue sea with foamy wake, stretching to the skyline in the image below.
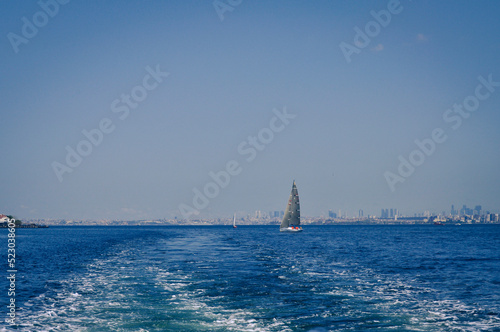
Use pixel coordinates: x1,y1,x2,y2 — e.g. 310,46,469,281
0,225,500,331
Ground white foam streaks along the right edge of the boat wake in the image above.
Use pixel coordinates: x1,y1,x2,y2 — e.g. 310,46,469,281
323,268,500,332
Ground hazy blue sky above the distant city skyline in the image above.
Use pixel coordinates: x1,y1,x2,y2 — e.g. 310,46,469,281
0,0,500,220
